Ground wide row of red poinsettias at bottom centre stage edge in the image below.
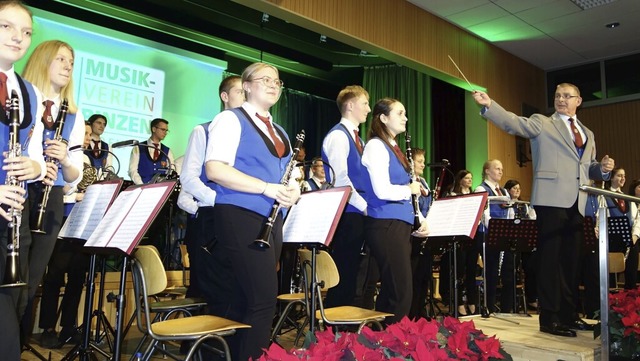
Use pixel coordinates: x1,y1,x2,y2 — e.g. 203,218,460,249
258,317,512,361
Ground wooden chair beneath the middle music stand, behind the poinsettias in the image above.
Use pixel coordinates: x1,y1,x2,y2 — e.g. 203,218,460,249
298,249,393,333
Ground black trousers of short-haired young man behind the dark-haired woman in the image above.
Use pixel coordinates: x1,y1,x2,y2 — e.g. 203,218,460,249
325,212,365,307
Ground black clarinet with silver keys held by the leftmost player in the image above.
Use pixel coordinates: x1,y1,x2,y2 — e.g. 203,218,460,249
0,90,27,287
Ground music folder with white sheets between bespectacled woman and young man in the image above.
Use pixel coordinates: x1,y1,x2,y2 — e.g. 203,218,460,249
282,187,351,246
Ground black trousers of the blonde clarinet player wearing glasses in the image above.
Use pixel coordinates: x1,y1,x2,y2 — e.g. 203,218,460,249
209,204,282,361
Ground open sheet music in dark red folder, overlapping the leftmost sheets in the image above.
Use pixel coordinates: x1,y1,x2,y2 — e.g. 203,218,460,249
85,182,175,253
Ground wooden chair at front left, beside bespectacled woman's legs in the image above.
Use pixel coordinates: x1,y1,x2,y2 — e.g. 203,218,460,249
131,248,251,361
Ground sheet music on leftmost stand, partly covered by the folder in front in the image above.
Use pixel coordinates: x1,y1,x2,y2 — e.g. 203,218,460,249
59,182,122,240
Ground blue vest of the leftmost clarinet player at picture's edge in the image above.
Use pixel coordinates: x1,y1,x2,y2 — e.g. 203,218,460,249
0,74,41,183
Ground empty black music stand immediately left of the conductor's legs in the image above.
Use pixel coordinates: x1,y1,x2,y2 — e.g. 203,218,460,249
484,218,538,316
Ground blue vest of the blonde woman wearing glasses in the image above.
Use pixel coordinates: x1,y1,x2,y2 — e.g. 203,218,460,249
213,108,291,217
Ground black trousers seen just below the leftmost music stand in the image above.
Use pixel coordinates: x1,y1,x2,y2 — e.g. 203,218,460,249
39,239,89,330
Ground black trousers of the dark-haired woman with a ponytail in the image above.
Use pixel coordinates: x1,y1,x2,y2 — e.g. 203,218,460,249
364,217,413,323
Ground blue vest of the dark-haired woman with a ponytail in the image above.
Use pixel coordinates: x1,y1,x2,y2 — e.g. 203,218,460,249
364,139,414,224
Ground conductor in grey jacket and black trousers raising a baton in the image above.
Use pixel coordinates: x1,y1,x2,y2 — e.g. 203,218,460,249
473,83,615,337
